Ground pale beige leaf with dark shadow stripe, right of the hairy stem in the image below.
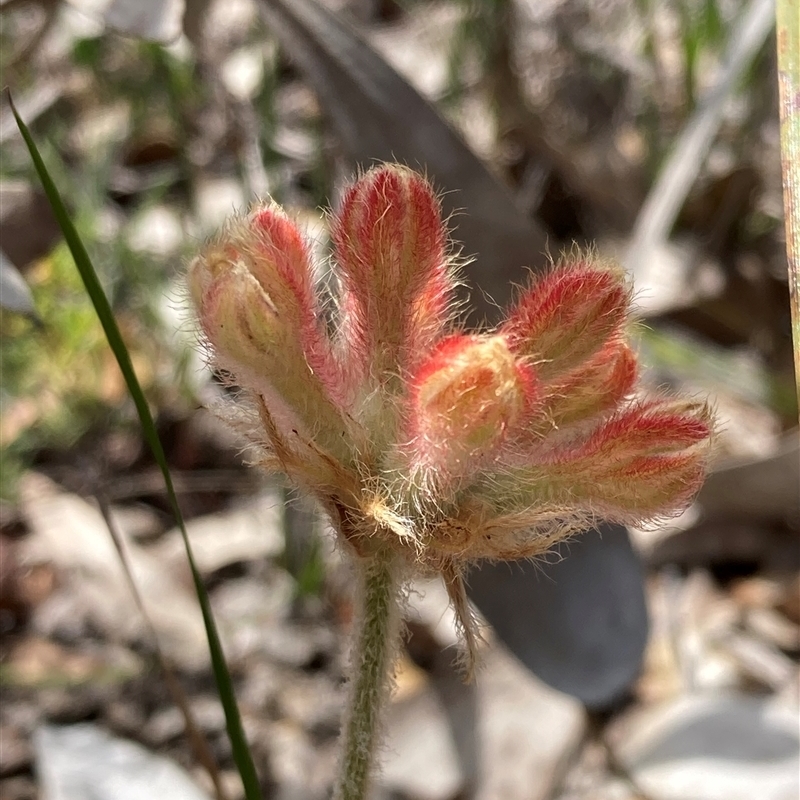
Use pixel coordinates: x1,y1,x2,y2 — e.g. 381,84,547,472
381,644,585,800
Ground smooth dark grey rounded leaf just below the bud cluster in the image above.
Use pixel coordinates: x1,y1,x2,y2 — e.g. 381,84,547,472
468,525,648,708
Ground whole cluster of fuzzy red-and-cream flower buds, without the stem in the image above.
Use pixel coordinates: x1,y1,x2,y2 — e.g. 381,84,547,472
188,165,713,656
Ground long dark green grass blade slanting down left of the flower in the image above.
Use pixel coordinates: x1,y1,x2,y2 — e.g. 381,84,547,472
9,95,261,800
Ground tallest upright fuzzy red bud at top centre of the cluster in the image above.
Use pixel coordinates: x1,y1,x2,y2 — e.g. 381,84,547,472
331,165,454,382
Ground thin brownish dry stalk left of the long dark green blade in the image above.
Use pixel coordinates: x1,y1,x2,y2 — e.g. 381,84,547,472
95,491,229,800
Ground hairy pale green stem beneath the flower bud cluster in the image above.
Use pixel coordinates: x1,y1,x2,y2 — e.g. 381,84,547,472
333,555,399,800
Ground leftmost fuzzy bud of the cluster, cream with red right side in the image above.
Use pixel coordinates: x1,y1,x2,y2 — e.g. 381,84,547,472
188,206,344,456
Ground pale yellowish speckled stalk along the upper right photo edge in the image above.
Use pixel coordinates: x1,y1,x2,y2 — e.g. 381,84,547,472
776,0,800,406
